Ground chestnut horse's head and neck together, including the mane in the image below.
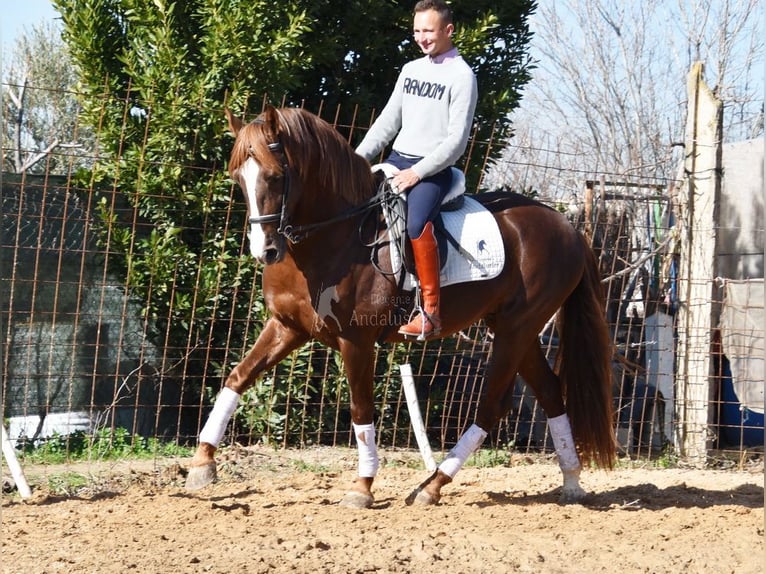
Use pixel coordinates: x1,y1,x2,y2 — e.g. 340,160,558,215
226,106,375,265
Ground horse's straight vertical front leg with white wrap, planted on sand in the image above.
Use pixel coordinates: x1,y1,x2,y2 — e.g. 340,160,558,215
340,339,380,508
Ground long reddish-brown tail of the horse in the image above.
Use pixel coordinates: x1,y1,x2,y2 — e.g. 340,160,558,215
558,237,616,468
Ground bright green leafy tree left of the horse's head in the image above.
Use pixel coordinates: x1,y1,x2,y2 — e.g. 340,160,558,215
54,0,320,396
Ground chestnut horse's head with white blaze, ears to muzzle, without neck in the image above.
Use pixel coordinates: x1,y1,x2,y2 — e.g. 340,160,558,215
226,106,290,265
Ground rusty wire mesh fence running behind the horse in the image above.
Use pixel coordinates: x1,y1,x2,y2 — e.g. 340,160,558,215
0,84,763,472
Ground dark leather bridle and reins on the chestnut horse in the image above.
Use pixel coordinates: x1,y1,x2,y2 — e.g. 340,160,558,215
247,137,386,243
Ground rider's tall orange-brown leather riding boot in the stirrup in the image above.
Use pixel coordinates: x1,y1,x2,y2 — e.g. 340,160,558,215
399,221,442,341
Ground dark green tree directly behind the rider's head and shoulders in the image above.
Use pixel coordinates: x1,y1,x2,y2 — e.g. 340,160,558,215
293,0,536,140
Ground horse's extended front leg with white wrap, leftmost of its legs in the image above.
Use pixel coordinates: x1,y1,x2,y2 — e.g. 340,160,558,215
186,318,308,490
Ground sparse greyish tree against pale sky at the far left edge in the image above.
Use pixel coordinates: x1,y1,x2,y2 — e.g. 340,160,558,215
2,23,89,174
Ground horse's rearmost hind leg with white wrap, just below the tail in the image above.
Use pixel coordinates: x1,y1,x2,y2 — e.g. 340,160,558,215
519,345,586,504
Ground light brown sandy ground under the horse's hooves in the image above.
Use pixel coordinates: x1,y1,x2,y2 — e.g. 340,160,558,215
2,449,766,574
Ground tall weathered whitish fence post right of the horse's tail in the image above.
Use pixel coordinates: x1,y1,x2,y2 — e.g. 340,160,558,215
676,62,723,466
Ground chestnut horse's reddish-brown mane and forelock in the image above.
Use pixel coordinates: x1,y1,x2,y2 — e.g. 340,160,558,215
229,108,374,204
